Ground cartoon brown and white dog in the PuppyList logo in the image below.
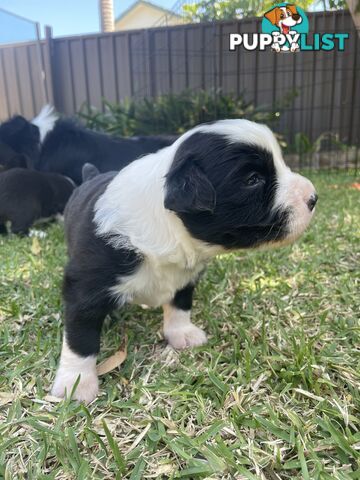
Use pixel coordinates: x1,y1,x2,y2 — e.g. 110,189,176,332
264,4,303,52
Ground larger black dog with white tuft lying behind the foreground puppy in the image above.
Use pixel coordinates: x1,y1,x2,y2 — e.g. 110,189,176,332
0,105,178,185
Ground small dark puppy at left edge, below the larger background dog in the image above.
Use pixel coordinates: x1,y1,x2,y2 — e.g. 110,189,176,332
0,168,75,235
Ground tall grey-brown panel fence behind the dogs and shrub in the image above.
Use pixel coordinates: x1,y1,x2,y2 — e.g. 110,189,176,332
0,11,360,150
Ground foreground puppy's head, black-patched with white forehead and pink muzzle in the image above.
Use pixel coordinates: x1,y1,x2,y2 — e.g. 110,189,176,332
164,120,317,249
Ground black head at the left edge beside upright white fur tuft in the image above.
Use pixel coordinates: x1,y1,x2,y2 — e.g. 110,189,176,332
0,115,40,170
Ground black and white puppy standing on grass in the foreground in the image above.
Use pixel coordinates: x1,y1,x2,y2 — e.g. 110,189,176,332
52,120,317,402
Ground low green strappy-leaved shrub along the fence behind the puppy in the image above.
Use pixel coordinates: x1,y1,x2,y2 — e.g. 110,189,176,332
79,90,282,136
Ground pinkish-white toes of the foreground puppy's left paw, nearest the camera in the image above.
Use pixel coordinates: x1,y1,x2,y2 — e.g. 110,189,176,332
51,367,99,403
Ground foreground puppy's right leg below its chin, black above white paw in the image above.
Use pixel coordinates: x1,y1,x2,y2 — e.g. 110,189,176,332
163,285,207,349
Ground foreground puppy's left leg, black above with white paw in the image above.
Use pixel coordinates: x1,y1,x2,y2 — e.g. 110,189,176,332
51,268,111,403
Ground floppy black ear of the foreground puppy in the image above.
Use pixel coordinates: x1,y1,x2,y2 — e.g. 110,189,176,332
164,157,216,213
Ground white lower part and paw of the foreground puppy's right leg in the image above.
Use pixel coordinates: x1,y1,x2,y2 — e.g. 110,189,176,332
163,305,207,349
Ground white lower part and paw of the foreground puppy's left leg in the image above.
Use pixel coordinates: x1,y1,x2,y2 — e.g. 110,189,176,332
51,336,99,403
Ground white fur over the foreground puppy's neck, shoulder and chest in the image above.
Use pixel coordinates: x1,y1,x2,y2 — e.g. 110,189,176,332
94,143,221,306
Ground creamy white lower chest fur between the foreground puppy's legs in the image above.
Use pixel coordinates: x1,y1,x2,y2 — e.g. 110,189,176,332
111,260,205,307
